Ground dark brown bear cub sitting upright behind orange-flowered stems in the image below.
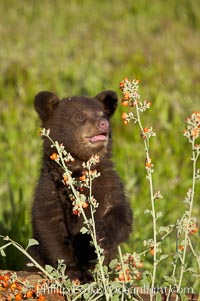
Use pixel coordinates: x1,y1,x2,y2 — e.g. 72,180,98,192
30,91,132,282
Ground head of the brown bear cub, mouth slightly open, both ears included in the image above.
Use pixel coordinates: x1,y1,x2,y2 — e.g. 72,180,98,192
34,90,118,161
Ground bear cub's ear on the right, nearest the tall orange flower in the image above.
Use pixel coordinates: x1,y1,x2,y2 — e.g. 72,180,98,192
95,90,118,117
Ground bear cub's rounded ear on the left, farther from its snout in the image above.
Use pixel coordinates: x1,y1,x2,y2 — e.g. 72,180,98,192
34,91,59,121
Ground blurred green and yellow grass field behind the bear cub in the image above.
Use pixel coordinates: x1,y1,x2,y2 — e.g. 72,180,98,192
0,0,200,286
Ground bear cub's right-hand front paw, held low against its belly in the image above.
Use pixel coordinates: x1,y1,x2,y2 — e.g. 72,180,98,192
96,221,114,253
